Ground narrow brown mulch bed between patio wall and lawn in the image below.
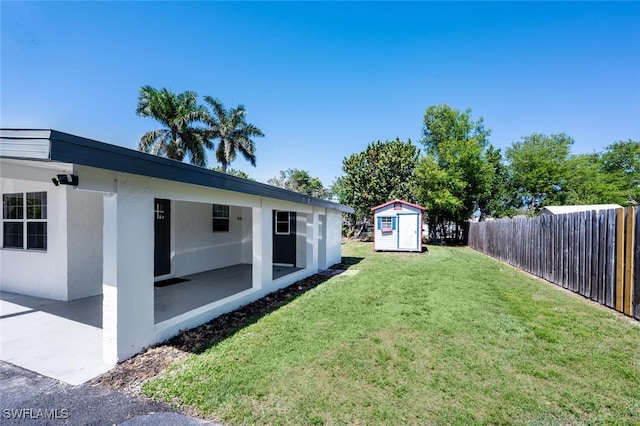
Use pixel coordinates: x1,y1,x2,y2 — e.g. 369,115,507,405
91,263,351,396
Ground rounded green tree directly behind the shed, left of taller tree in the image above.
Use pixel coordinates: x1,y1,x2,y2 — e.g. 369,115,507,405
333,138,420,235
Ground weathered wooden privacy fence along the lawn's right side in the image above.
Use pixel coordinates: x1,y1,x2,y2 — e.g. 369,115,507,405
469,207,640,320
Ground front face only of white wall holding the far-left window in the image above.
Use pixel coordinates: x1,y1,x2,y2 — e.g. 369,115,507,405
0,175,68,300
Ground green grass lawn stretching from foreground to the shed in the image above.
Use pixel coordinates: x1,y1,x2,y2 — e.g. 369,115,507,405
144,242,640,425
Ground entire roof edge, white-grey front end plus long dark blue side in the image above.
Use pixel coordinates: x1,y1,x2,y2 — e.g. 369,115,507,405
0,129,354,213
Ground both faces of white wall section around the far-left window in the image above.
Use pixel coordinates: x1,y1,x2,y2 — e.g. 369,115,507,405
0,161,103,301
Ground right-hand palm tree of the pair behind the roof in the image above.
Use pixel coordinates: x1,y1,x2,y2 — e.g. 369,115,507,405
204,96,264,173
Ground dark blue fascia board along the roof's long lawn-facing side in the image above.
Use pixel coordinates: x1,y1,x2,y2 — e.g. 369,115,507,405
38,130,354,213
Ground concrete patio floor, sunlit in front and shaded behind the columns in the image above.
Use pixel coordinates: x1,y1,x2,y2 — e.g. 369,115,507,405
0,264,301,385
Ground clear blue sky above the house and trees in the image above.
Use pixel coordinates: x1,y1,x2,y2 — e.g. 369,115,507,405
0,1,640,185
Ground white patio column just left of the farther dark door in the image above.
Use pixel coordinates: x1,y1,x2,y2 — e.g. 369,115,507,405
252,200,273,289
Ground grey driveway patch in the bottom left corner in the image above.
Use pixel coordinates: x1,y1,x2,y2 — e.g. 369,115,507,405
0,361,212,426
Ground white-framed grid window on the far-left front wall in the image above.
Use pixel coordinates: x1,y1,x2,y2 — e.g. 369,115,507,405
2,192,47,250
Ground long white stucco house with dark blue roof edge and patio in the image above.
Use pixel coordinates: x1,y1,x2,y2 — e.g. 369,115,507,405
0,129,353,374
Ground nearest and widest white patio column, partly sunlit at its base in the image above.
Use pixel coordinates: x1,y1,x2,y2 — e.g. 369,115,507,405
102,179,154,364
